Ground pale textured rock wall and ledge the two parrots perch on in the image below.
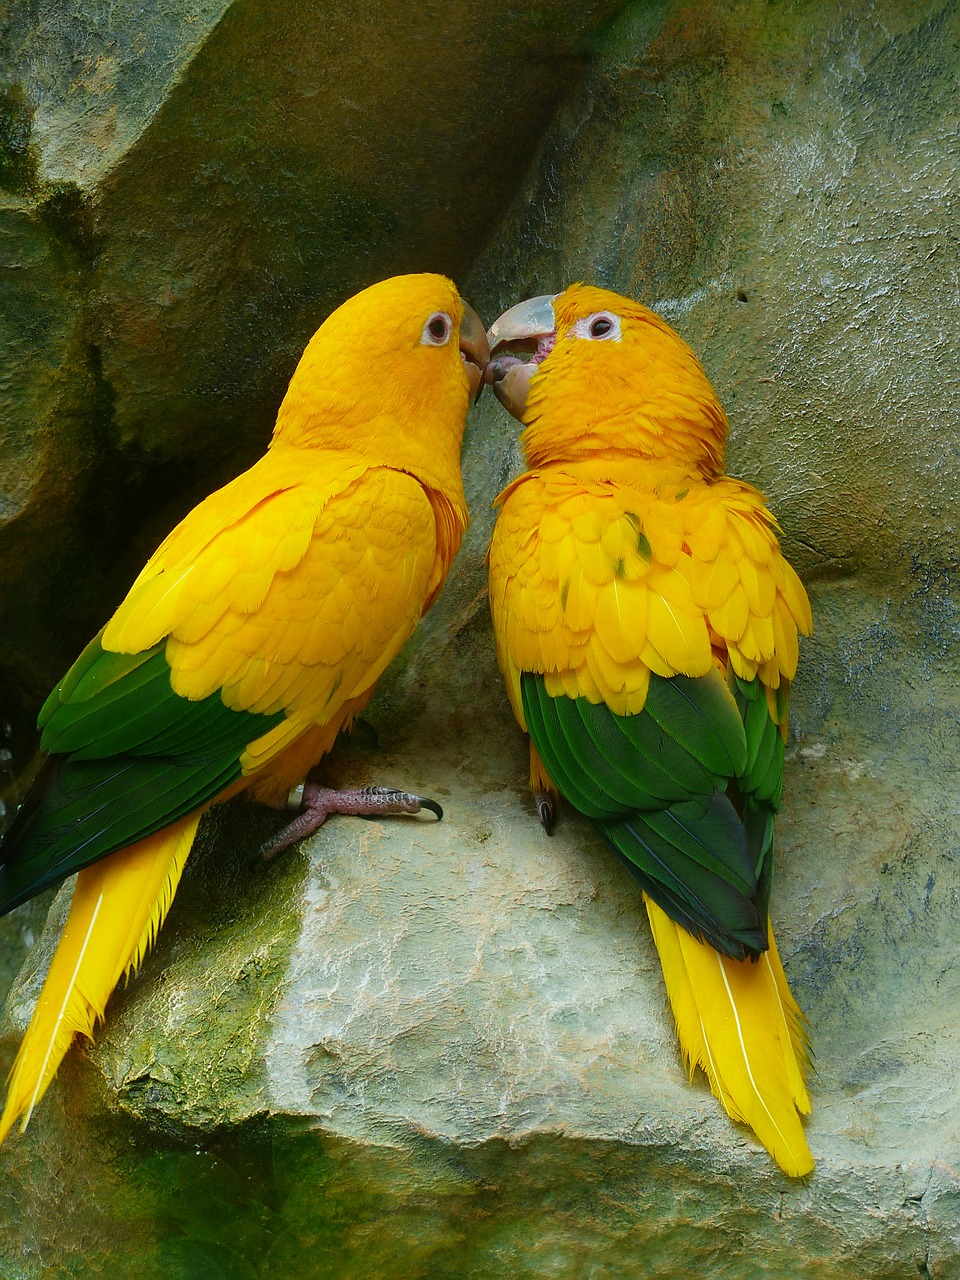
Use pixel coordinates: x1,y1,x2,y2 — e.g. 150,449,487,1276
0,0,960,1280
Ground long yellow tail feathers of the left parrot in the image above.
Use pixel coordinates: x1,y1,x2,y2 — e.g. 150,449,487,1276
0,814,200,1143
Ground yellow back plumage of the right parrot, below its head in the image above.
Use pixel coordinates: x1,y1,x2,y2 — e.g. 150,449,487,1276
489,460,812,724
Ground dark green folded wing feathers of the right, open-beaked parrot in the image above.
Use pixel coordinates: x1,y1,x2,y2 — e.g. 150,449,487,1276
521,671,783,960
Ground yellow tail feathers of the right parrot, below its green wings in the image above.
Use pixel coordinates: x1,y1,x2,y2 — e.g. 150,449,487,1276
645,897,813,1178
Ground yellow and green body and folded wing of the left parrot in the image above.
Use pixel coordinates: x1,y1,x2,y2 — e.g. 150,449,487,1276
0,454,436,910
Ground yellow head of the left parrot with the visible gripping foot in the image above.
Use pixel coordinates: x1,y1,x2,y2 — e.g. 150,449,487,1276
271,273,489,486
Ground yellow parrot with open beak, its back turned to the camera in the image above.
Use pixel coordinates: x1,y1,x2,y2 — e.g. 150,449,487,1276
486,284,813,1178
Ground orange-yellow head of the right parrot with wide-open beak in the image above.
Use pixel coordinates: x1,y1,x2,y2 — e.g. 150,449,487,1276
484,284,727,475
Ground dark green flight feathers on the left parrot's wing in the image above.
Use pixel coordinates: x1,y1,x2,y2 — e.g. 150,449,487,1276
0,636,283,914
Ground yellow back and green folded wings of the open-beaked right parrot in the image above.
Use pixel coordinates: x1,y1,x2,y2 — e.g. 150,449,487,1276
490,477,806,957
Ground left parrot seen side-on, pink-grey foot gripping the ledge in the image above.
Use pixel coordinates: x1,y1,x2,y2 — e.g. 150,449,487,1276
0,274,488,1140
